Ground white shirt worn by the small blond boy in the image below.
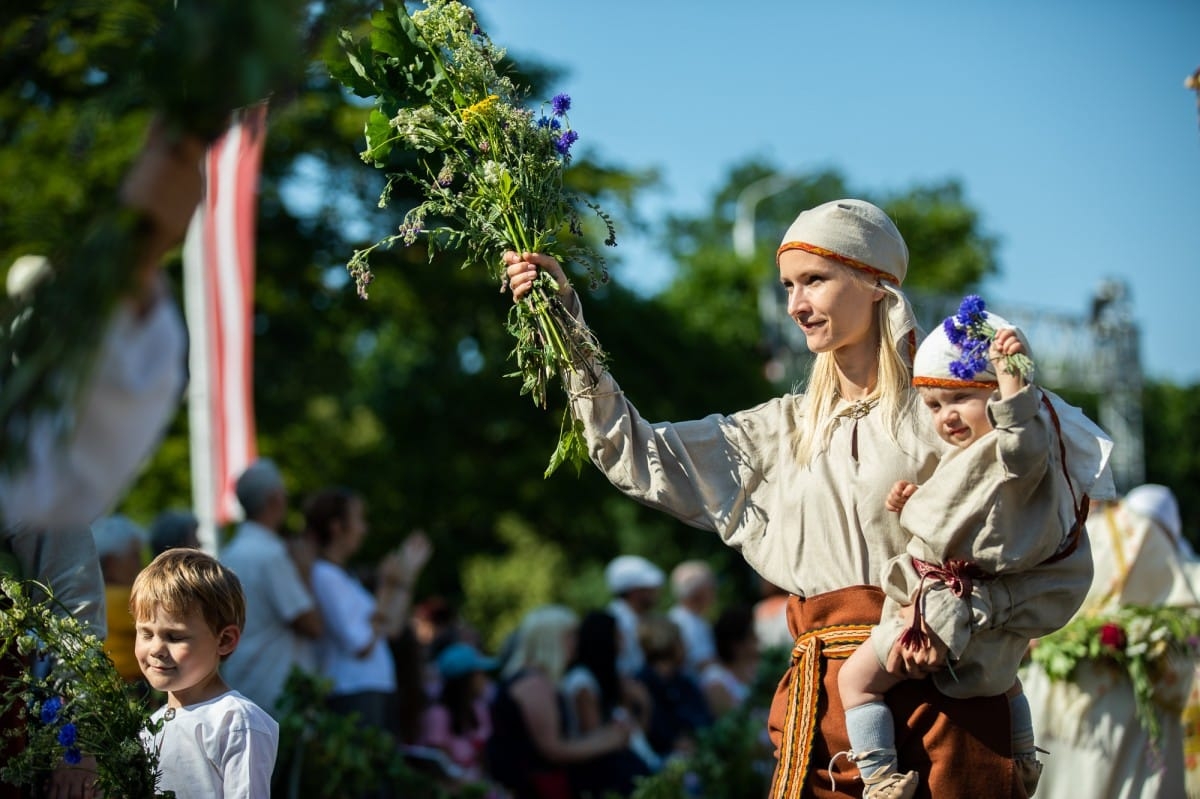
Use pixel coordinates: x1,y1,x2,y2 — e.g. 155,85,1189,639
142,691,280,799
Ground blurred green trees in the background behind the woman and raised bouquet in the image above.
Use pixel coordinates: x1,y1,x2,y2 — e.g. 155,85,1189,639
7,0,1195,652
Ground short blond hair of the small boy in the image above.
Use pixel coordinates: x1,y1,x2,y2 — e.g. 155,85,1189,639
130,548,246,635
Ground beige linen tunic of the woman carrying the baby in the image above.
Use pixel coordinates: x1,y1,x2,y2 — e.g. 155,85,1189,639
566,295,1091,671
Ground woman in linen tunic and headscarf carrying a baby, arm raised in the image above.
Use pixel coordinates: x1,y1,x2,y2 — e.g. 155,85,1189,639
506,199,1091,799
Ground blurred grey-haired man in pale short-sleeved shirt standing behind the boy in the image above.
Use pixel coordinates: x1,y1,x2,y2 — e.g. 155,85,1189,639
220,458,324,716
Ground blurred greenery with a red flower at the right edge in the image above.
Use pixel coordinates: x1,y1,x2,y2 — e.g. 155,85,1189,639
1031,605,1200,745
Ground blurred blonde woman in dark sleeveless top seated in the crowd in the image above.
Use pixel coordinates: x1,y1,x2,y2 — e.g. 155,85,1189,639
487,605,632,799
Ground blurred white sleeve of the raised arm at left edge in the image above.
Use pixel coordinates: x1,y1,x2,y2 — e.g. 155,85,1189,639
0,300,186,528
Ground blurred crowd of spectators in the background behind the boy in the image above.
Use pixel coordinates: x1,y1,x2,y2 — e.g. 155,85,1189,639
82,458,790,799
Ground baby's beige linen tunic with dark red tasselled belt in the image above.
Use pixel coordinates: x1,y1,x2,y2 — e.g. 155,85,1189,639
871,385,1091,698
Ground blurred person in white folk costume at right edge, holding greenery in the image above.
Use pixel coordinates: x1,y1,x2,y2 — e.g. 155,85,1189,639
1021,485,1200,799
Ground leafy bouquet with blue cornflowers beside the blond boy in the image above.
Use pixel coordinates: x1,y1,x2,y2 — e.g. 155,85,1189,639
0,577,174,799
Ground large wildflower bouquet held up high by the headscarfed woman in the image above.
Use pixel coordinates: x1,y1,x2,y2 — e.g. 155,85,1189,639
330,0,616,475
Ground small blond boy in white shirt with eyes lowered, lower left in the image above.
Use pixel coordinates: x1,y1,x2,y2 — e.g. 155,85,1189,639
130,549,280,799
